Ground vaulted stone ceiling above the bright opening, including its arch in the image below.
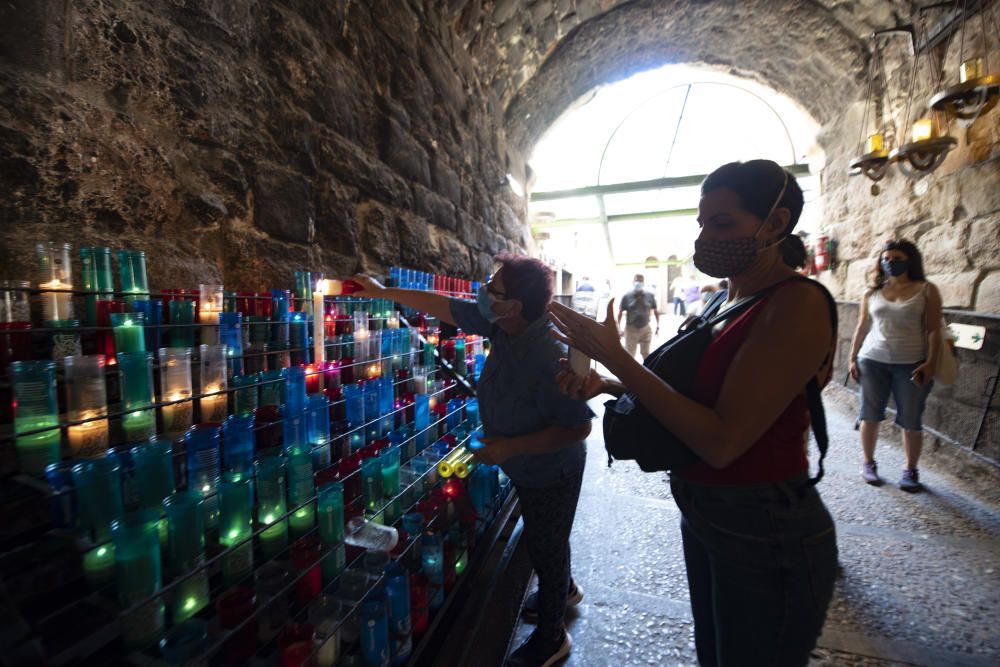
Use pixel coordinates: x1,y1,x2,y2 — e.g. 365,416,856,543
450,0,912,151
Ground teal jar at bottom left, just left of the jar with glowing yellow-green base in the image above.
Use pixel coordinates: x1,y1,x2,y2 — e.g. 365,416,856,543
111,510,164,649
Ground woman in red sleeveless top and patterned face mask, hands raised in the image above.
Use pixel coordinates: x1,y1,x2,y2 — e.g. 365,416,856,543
549,160,837,667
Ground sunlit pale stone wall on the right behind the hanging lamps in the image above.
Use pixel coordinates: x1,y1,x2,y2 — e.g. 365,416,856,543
820,21,1000,313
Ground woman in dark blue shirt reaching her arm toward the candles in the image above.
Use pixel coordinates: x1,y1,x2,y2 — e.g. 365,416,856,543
354,255,593,667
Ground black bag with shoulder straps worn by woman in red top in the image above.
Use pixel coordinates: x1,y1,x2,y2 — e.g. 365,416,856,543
604,280,837,484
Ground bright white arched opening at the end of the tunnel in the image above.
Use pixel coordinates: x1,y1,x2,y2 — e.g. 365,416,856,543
529,65,824,320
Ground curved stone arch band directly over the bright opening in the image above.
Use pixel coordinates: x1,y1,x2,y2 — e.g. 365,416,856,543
506,0,867,156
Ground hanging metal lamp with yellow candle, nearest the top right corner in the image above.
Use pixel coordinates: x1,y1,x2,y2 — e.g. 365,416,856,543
930,0,1000,127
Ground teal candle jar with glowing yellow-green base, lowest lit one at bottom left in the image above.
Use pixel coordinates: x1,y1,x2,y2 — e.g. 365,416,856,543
163,491,209,625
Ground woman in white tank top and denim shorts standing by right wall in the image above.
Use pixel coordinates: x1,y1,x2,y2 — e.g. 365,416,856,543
851,240,941,491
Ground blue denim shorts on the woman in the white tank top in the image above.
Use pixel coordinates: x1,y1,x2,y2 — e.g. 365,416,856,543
858,357,934,431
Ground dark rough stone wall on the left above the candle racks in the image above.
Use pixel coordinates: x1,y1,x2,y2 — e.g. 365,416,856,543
0,0,528,289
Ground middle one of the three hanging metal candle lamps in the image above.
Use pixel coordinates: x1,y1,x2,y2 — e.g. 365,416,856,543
889,5,958,178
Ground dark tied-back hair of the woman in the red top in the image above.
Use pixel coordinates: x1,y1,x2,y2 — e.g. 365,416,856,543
701,160,806,269
